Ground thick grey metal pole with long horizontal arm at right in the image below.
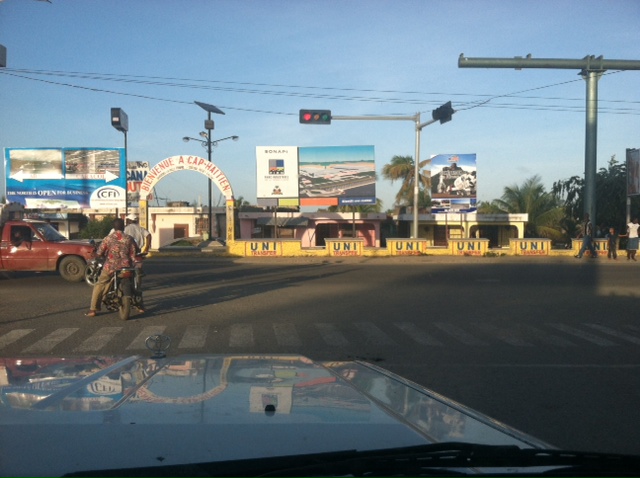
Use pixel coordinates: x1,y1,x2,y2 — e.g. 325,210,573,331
458,54,640,227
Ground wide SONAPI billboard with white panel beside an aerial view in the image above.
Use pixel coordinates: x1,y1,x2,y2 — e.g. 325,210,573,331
256,146,376,206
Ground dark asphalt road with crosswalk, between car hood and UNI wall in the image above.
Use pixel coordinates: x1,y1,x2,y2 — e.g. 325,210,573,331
0,255,640,453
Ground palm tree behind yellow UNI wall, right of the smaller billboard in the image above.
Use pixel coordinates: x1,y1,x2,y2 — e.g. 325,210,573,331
478,175,569,241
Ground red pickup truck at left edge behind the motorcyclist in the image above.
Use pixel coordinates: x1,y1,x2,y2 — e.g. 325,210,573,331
0,206,95,282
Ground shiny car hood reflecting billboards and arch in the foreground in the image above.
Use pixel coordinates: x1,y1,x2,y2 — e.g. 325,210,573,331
0,355,548,477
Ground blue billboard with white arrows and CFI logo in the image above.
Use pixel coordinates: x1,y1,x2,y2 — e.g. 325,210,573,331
4,148,127,209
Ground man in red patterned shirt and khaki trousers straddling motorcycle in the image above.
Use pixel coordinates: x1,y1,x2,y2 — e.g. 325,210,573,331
84,218,136,317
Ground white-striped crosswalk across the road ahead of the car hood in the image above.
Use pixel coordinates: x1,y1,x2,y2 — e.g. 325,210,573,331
0,321,640,356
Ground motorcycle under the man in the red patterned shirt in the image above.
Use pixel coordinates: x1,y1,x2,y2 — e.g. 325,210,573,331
85,254,146,320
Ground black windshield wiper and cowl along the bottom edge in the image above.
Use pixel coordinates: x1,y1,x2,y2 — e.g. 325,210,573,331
64,442,640,478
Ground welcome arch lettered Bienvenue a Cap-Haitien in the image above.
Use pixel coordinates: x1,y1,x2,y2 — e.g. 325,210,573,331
140,156,235,242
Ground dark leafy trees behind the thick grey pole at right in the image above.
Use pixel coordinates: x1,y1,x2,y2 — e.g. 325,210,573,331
552,155,640,231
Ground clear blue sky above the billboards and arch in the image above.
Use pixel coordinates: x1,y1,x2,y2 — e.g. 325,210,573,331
0,0,640,210
